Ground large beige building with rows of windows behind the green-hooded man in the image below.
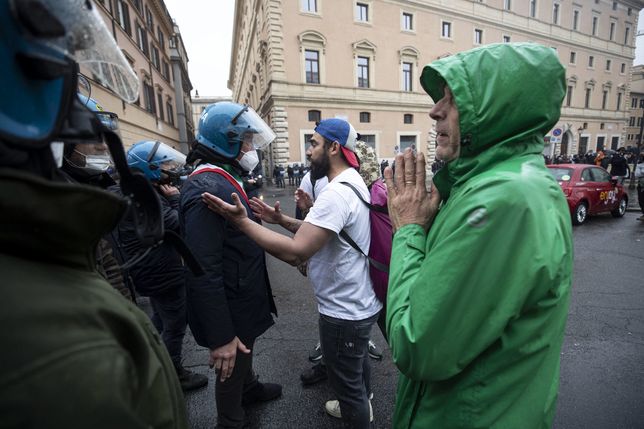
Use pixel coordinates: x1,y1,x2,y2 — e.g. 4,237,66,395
228,0,644,171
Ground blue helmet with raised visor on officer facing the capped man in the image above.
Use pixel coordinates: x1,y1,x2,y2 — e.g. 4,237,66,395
191,101,275,160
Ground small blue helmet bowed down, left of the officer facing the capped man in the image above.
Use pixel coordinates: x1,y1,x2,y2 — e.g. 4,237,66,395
127,140,186,183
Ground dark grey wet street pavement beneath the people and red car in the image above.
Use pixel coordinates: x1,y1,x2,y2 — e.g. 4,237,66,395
180,188,644,429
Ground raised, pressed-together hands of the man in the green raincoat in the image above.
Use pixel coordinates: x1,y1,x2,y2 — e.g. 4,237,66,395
385,148,441,232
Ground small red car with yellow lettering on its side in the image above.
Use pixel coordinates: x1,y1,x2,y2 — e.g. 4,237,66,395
547,164,628,225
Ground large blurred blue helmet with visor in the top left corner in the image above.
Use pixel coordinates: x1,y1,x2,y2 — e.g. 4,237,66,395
0,0,138,148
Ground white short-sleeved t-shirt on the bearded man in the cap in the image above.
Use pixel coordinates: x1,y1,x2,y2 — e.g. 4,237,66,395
304,168,382,320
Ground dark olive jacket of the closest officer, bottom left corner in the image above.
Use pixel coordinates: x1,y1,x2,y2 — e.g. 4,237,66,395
0,168,188,429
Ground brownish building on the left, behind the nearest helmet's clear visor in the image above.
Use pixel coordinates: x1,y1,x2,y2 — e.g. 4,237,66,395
90,0,194,152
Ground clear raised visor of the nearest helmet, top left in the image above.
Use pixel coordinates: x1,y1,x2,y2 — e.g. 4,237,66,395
39,0,139,103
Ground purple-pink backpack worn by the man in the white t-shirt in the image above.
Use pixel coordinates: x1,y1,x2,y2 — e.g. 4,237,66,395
340,179,393,302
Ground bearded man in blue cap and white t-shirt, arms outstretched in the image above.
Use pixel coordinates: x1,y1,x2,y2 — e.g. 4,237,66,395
204,118,382,428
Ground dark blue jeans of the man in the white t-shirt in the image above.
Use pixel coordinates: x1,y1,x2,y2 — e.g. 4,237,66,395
320,314,378,428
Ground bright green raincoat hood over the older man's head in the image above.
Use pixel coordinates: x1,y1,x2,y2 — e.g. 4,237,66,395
420,43,566,200
